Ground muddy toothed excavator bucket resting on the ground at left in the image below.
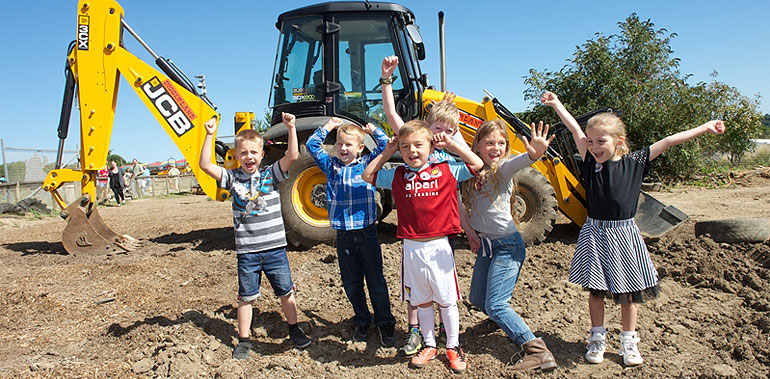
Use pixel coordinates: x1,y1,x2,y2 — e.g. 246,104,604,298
61,194,141,255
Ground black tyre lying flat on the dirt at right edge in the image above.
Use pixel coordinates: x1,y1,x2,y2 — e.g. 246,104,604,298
695,217,770,243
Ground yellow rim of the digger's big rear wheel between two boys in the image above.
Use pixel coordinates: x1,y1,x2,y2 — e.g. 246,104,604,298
291,167,329,227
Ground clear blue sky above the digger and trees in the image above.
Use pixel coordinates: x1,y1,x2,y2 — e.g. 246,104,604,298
0,0,770,162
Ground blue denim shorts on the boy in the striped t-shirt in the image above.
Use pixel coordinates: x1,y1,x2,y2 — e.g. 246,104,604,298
238,247,294,303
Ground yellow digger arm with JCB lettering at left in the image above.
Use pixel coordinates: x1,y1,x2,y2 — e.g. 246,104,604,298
43,0,228,208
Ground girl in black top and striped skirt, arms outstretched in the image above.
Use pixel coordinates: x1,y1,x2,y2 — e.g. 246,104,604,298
541,92,725,366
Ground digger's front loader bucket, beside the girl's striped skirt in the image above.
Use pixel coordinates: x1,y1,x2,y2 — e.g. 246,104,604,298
634,191,690,238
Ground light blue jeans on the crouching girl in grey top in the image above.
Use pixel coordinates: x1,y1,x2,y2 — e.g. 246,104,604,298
468,232,535,346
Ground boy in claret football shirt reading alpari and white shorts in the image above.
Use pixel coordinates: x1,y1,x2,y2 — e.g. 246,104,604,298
361,120,484,373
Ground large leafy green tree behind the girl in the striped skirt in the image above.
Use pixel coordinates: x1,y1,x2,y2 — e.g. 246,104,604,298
525,13,757,176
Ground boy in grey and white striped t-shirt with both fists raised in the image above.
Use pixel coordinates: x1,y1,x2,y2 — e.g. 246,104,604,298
200,113,310,359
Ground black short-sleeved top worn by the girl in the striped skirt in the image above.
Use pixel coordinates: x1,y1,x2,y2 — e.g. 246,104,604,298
580,147,650,220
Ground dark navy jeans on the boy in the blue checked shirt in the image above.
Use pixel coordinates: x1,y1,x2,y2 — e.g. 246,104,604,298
337,224,396,327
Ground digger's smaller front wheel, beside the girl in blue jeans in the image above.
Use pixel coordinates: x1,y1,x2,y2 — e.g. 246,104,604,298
511,167,559,246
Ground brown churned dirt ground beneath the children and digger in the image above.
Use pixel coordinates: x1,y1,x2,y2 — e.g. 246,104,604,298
0,168,770,378
